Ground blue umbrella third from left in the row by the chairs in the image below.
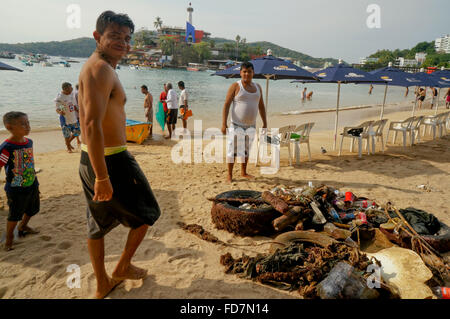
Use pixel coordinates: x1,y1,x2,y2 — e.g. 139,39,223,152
369,63,426,120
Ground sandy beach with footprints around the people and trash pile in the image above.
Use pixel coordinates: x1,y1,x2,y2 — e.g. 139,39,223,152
0,102,450,298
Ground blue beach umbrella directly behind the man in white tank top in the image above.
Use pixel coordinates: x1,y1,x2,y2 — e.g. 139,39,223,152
212,50,317,110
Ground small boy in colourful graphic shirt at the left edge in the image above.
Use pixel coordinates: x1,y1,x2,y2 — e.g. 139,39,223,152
0,112,40,251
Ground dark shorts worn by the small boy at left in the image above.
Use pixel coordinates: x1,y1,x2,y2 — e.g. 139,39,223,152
6,186,41,222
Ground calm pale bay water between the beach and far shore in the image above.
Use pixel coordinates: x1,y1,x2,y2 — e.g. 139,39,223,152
0,58,412,129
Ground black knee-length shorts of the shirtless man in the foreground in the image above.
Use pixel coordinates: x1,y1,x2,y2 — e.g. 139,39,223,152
79,151,161,239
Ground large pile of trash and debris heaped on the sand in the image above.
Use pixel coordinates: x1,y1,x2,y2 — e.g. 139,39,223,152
205,183,450,298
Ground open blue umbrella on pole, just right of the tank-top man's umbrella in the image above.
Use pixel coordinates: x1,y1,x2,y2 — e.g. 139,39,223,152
293,60,386,150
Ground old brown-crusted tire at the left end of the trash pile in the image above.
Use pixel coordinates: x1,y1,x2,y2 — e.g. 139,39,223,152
211,190,281,236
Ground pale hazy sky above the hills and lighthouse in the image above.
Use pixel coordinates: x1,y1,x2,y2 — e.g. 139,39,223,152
0,0,450,63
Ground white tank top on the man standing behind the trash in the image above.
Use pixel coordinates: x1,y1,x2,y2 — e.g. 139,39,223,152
231,81,261,127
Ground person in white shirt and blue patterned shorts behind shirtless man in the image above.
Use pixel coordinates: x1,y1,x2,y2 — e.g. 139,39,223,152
55,82,81,153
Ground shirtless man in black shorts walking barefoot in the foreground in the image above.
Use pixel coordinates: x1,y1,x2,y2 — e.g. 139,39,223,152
79,11,160,298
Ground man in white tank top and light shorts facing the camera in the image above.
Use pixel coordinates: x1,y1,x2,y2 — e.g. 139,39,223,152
222,62,267,183
